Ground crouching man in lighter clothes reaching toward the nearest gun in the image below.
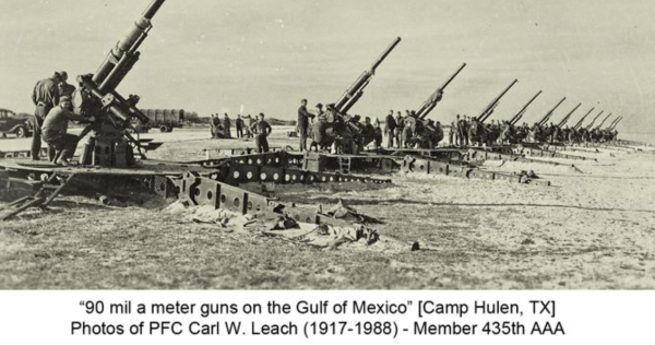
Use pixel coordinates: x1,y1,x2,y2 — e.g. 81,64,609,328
41,96,95,166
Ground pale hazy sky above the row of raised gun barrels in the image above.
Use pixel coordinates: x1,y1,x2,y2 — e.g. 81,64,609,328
0,0,655,132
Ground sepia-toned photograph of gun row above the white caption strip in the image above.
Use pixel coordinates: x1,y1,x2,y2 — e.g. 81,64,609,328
0,0,655,290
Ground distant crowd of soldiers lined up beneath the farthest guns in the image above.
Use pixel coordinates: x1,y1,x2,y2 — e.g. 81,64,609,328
449,114,618,147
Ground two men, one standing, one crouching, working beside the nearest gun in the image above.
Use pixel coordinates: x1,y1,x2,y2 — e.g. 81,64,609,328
30,72,89,166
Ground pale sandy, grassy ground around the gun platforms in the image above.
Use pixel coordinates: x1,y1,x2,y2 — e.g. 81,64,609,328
0,128,655,289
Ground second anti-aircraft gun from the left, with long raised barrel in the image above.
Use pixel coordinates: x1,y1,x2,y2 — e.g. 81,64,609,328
312,37,401,153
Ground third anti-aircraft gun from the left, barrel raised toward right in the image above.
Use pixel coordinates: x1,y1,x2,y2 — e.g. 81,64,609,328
407,63,466,149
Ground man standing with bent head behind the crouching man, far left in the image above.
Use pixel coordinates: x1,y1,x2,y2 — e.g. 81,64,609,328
31,72,60,161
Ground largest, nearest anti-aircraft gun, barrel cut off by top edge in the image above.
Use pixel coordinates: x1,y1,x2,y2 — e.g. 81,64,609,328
73,0,165,167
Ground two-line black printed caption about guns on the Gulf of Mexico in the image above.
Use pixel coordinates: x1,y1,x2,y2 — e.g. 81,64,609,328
70,299,566,338
